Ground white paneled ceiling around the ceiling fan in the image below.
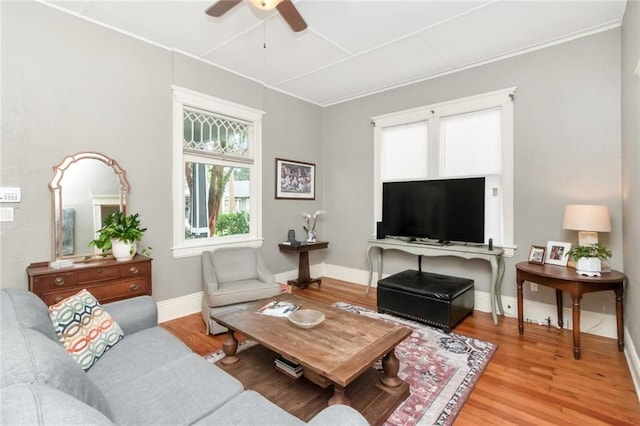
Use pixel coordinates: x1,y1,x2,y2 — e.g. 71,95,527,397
41,0,626,106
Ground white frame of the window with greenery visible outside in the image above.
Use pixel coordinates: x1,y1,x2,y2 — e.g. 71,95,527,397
171,85,264,258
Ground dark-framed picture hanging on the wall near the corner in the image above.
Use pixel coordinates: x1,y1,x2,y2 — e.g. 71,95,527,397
276,158,316,200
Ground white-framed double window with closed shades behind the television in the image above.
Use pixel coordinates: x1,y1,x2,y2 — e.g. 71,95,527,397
373,88,515,256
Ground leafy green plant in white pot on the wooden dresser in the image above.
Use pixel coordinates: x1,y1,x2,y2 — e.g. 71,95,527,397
89,212,147,260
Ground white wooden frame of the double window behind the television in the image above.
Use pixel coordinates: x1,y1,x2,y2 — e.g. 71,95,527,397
371,87,516,257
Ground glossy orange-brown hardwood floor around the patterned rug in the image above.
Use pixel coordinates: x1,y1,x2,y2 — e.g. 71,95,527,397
161,278,640,425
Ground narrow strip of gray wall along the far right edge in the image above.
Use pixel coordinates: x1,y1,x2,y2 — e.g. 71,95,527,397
621,0,640,352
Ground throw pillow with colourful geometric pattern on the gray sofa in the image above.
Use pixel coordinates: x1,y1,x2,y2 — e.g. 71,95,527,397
49,289,124,371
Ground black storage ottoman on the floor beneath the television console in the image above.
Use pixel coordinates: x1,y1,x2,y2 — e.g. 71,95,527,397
378,270,474,333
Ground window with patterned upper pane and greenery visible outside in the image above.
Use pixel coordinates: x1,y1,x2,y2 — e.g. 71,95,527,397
173,87,263,257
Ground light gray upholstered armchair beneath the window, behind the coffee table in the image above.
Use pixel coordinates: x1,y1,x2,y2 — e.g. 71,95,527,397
202,247,280,334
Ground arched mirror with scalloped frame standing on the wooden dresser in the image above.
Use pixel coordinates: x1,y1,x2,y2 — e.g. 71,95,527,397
49,152,129,260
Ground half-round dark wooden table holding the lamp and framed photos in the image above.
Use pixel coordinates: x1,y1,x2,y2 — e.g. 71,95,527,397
516,262,627,359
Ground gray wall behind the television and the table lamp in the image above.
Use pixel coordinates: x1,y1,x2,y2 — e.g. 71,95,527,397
324,29,622,314
